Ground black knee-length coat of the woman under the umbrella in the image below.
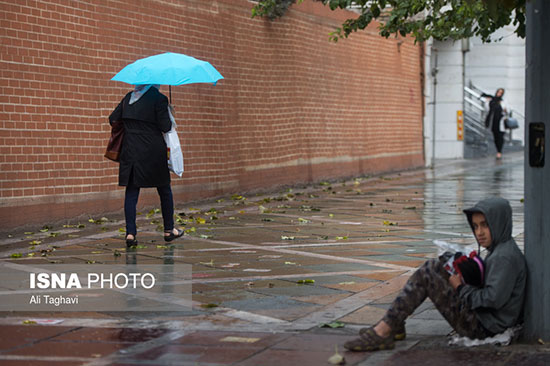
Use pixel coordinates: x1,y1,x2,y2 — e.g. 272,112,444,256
109,87,172,187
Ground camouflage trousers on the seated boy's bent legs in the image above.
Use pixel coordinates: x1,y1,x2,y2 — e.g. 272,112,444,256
382,259,492,339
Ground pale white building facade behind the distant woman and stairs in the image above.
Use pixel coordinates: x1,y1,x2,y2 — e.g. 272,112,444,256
424,27,525,166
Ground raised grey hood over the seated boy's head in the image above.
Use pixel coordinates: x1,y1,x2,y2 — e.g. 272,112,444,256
464,197,512,250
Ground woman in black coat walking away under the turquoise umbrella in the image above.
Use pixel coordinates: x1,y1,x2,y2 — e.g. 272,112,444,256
109,85,183,247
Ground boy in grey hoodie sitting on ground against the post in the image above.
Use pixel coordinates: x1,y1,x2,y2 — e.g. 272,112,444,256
344,198,527,351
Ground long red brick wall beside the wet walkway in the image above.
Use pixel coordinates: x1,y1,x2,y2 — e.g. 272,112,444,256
0,0,423,228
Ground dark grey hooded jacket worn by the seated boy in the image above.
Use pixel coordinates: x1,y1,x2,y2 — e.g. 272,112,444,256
460,198,527,334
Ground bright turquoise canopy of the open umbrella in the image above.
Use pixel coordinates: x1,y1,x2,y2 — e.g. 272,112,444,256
111,52,223,85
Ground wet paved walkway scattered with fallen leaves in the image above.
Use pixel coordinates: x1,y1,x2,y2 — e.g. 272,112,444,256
0,153,550,366
